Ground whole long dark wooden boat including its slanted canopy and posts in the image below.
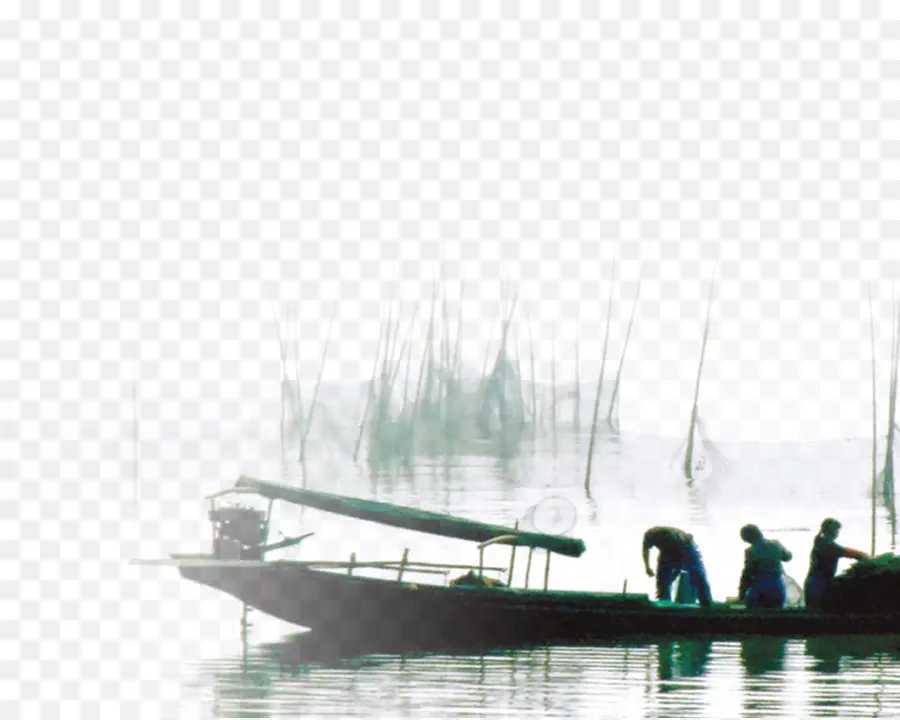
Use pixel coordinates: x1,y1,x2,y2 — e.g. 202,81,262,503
139,477,900,652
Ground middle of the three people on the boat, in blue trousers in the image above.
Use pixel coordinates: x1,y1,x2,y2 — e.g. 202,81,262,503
738,525,794,609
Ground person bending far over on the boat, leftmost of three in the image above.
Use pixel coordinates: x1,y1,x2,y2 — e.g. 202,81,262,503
643,526,712,607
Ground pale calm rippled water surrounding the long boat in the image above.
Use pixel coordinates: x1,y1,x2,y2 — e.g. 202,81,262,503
21,430,900,718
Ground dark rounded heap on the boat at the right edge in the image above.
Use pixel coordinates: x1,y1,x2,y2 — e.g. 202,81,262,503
823,553,900,613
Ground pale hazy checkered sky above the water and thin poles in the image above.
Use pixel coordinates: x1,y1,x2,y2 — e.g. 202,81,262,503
8,2,900,466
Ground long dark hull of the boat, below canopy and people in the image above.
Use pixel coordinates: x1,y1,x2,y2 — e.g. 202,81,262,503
179,556,900,652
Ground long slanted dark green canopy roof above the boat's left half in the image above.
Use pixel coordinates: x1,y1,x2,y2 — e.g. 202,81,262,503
235,476,585,557
